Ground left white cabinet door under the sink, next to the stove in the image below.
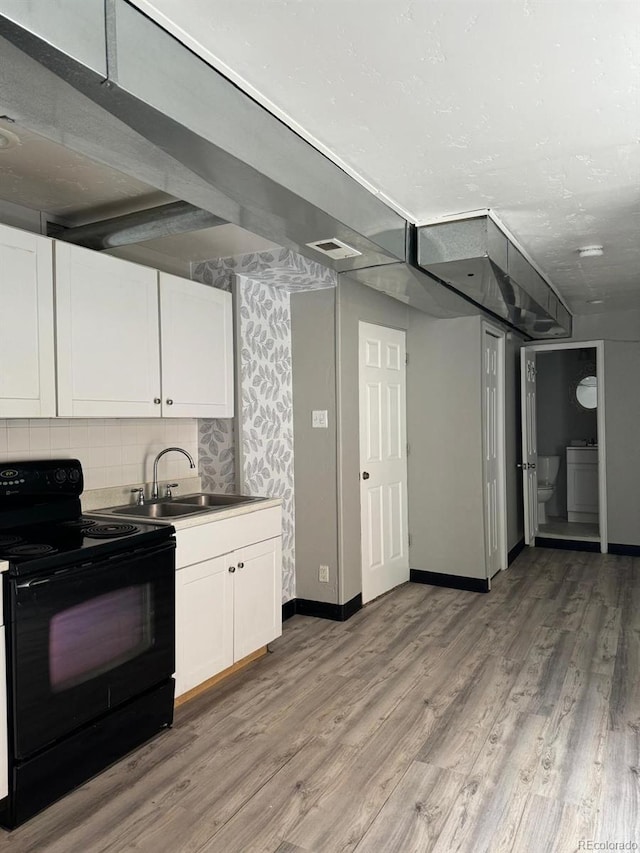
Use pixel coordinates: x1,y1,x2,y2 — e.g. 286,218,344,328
176,556,233,696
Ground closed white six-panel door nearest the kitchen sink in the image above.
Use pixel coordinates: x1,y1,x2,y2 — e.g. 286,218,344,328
359,322,409,602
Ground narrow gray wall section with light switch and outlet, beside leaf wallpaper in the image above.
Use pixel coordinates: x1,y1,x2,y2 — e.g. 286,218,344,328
291,290,338,604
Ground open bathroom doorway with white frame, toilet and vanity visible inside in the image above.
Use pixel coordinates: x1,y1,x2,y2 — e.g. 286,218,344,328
522,341,608,553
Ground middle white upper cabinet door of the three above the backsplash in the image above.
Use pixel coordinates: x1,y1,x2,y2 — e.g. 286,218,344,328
55,242,161,417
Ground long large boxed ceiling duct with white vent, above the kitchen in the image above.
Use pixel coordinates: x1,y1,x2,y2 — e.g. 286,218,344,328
0,0,406,271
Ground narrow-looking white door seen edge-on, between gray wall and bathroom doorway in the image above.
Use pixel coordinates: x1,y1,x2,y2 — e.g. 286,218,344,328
482,328,506,578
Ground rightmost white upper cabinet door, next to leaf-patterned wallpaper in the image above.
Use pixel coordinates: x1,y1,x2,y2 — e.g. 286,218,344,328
160,273,233,418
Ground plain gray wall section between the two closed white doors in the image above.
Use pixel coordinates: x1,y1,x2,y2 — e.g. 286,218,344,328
407,312,486,578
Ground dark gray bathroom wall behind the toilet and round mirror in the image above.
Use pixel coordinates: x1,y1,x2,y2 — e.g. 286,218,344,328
536,349,598,518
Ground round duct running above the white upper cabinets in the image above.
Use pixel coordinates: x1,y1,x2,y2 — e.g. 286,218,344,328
49,201,225,251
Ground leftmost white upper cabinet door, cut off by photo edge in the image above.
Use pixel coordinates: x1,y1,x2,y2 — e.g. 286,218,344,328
0,225,56,418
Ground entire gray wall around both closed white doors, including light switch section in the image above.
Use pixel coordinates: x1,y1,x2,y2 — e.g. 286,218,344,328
291,279,523,604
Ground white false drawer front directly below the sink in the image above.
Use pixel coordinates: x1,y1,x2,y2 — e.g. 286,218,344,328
176,506,282,569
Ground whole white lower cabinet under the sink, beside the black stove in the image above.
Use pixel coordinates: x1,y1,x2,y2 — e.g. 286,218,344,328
176,508,282,696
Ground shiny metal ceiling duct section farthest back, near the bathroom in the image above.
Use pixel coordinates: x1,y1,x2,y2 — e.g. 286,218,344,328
416,214,571,339
